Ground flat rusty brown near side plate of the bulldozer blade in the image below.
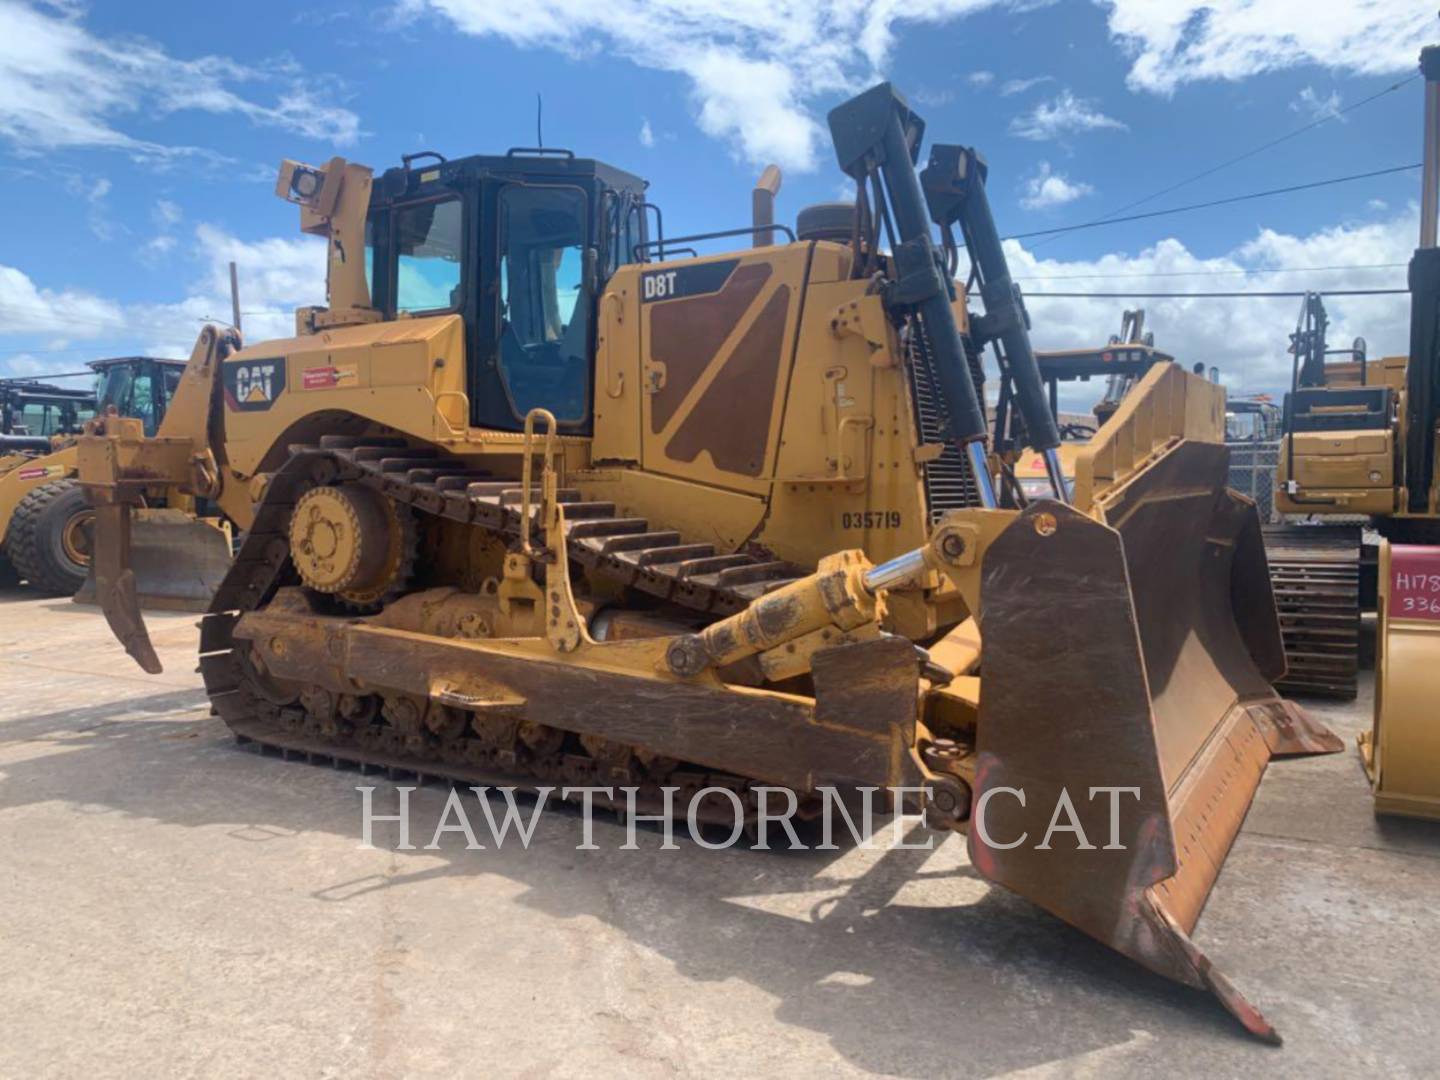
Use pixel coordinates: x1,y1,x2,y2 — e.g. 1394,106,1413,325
969,504,1175,973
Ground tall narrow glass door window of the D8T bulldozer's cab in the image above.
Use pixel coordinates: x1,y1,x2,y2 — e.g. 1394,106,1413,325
500,184,590,423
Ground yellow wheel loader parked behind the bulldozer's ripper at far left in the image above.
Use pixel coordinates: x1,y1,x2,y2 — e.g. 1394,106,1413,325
0,356,230,601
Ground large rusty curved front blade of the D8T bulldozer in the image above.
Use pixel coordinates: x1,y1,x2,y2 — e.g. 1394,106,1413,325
969,442,1342,1041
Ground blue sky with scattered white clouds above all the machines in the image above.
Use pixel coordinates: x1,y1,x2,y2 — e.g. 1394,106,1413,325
0,0,1440,400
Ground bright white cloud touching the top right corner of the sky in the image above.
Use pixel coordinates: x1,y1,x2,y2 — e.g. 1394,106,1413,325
1102,0,1434,94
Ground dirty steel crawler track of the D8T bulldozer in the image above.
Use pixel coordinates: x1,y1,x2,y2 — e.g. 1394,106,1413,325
200,436,823,824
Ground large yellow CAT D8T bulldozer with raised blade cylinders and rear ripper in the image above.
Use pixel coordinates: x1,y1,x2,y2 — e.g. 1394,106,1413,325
81,84,1341,1040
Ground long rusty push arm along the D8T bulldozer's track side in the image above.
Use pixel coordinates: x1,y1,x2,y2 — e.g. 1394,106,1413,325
235,601,919,791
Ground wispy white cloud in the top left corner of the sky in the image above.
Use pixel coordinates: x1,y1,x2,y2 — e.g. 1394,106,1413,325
0,0,360,163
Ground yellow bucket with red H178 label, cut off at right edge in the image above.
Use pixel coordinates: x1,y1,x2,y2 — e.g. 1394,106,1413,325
1359,541,1440,819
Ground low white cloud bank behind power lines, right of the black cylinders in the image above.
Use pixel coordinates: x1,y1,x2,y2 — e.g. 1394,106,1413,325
1005,206,1418,409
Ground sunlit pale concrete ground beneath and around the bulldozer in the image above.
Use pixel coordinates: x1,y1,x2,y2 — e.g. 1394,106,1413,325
0,592,1440,1077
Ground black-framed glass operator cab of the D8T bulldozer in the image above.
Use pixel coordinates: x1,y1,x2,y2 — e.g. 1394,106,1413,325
366,148,647,433
